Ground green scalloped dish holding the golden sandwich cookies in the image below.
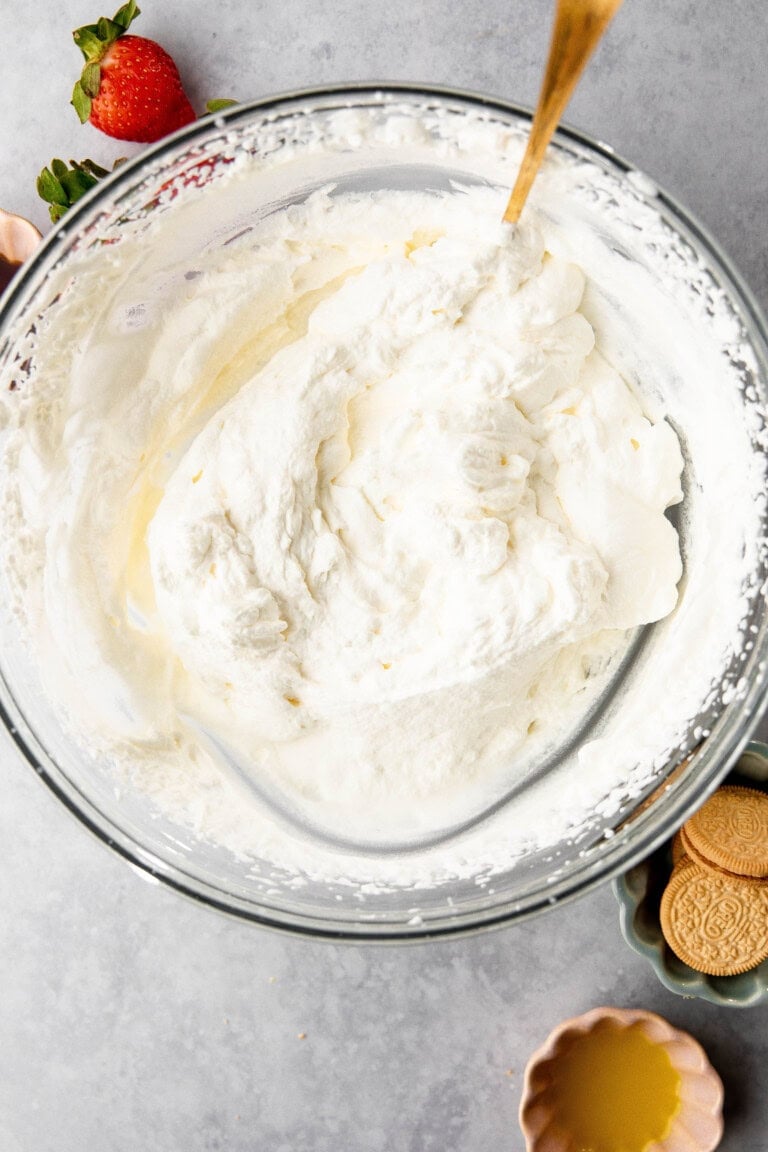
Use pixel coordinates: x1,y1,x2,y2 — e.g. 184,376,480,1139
613,743,768,1008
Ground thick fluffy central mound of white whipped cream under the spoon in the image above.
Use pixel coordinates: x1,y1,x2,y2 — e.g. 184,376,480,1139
147,192,682,836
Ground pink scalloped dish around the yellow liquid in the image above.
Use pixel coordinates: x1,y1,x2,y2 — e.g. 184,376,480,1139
519,1008,723,1152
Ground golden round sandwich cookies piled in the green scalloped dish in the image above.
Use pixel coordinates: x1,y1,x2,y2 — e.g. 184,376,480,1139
661,785,768,976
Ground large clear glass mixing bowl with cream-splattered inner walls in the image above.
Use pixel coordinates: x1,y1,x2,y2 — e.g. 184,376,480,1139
0,85,768,941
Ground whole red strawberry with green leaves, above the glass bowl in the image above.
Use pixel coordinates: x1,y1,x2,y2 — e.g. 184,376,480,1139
71,0,195,144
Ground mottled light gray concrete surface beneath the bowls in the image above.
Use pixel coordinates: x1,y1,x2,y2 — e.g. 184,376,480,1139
0,0,768,1152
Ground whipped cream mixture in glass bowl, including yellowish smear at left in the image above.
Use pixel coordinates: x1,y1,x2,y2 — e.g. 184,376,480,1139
0,189,683,844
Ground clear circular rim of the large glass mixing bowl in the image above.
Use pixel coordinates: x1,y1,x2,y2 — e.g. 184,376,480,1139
0,81,768,943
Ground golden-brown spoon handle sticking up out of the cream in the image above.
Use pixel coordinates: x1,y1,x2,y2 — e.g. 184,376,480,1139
503,0,622,223
